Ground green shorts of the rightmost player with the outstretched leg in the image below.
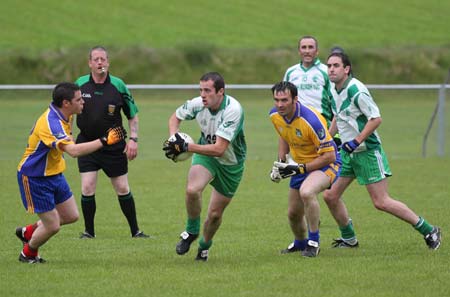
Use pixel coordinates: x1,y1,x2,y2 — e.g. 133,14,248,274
340,146,392,185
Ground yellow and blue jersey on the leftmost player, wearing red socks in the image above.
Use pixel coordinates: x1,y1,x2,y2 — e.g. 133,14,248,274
17,104,74,176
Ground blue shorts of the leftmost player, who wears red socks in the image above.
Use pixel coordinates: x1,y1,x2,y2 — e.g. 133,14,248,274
17,172,73,213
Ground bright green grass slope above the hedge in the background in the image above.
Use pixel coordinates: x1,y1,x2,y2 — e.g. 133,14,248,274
0,0,450,51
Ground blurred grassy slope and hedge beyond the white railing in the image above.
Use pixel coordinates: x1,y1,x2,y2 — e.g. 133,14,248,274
0,0,450,84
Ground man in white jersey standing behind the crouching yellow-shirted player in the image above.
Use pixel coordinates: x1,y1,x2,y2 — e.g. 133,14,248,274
283,36,333,125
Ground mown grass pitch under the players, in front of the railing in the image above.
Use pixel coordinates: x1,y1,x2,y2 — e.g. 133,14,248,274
0,90,450,297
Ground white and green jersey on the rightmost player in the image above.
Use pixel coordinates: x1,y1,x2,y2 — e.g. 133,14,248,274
331,76,381,152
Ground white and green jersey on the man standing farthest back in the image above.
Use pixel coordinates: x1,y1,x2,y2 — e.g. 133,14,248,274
283,59,333,124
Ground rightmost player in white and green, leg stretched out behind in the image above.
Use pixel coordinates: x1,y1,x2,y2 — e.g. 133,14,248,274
324,52,441,250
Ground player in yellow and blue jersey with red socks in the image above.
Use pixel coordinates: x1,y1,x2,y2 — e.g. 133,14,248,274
16,83,125,263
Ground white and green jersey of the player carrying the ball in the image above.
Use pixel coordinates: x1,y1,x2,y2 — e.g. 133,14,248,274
176,95,247,165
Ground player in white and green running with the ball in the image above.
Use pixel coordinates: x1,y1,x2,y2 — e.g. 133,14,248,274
163,72,247,261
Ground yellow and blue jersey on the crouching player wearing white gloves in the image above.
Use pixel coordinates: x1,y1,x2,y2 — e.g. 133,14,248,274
270,102,340,163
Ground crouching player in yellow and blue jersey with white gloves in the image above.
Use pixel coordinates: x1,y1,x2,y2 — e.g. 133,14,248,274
270,81,341,257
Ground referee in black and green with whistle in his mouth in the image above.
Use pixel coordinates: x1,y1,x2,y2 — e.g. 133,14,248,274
76,46,149,238
